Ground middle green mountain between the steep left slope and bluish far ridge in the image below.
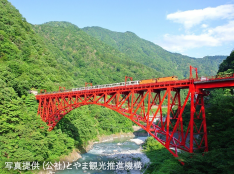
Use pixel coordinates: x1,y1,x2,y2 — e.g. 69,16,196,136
33,22,161,85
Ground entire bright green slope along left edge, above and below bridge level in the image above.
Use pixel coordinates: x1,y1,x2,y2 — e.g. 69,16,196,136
0,0,82,174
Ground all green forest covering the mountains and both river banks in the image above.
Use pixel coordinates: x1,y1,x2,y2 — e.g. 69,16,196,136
0,0,234,174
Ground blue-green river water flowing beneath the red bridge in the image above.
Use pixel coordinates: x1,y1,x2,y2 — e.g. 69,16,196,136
55,137,149,174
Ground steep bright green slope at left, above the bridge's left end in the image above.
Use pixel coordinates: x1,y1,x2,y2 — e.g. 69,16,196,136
0,0,80,96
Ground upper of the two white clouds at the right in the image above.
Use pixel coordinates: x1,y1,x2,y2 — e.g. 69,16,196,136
167,4,234,29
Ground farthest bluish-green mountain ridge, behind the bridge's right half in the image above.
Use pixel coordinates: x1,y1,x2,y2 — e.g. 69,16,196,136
82,27,227,78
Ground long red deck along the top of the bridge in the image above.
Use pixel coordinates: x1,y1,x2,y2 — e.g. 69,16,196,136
36,76,234,98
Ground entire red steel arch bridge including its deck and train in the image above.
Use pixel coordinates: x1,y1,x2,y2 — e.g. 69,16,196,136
36,66,234,156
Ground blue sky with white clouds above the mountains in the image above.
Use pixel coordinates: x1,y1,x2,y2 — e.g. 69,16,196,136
9,0,234,58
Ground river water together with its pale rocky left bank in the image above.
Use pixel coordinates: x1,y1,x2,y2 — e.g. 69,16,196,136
39,127,150,174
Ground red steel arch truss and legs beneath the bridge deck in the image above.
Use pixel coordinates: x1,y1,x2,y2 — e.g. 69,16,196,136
38,82,208,157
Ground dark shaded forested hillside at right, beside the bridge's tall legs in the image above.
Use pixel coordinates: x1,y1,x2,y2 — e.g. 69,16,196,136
145,51,234,174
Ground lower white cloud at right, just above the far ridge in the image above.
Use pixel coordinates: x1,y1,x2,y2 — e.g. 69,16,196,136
160,20,234,52
